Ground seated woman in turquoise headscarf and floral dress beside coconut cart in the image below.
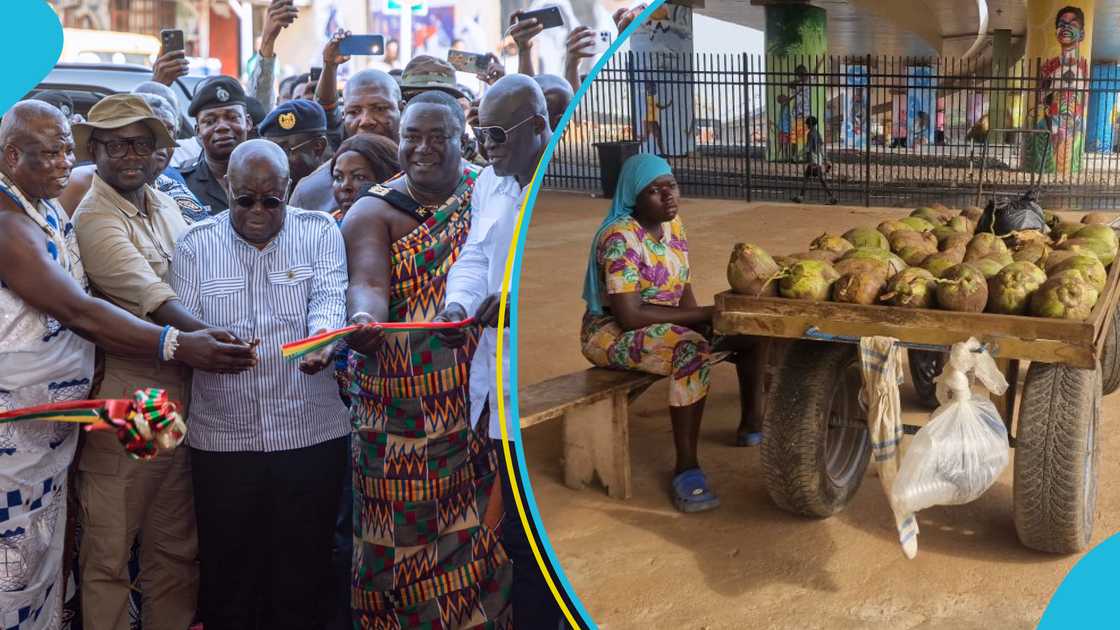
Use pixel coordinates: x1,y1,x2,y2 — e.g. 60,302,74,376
580,154,760,512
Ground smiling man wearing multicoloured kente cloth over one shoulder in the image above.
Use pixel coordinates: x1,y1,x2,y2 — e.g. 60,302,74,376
343,91,512,629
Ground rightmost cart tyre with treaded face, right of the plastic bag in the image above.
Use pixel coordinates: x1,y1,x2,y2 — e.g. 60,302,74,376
1014,363,1101,554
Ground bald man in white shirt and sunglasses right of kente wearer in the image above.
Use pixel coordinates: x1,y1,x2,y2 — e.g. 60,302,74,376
436,74,561,629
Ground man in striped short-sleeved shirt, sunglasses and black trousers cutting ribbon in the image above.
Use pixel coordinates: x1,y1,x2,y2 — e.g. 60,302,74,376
171,140,349,630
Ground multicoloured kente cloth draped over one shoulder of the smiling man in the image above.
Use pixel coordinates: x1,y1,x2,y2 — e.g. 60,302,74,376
348,166,513,630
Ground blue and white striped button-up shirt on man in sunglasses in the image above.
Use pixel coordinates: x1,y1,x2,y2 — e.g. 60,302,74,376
171,206,349,452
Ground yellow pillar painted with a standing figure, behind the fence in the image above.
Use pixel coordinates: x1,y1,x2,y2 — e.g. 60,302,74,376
1023,0,1096,178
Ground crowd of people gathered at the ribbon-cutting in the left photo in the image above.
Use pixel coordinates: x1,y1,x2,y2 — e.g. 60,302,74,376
0,2,636,630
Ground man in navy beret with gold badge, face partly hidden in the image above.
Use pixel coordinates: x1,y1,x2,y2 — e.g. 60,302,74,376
259,99,330,192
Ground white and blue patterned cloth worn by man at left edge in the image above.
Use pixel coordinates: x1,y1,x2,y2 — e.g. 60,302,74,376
0,175,93,630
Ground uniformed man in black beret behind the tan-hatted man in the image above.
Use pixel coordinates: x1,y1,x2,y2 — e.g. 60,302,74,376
181,76,253,214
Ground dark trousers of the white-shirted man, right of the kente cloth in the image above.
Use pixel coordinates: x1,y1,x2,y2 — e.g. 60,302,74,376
499,423,563,630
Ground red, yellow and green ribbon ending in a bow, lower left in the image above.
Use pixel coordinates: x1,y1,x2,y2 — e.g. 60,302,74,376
0,388,187,460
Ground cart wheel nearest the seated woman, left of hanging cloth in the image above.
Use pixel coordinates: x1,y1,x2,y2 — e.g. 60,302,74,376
762,341,871,517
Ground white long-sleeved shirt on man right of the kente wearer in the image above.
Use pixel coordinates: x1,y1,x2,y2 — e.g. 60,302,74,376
445,166,525,439
